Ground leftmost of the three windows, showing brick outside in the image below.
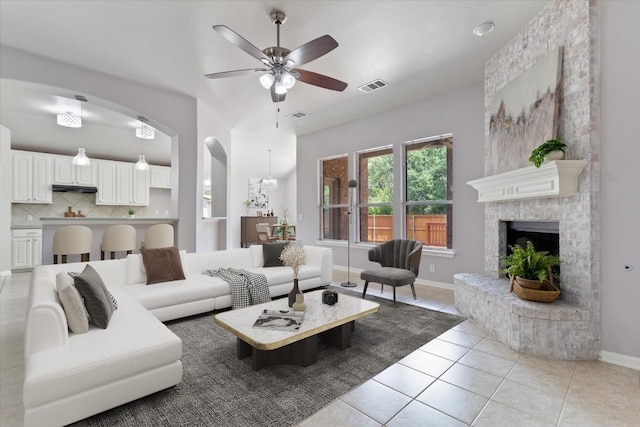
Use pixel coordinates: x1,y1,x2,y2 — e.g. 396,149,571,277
320,155,349,240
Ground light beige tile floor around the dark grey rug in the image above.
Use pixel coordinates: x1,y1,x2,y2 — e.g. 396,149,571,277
0,270,640,427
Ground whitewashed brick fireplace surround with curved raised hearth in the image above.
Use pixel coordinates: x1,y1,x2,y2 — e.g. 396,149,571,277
455,0,600,359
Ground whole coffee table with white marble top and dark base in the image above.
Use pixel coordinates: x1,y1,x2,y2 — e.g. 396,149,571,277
214,290,380,371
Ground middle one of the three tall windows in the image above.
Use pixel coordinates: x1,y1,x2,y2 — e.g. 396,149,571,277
356,147,393,243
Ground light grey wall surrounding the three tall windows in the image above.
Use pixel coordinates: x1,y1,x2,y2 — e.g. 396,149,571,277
297,84,484,283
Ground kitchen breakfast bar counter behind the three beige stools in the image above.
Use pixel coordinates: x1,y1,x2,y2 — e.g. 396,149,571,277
39,217,180,264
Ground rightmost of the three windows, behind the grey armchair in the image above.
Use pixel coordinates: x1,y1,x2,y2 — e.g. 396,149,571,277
404,135,453,249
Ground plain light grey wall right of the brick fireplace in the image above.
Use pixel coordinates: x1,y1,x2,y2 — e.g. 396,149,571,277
601,1,640,362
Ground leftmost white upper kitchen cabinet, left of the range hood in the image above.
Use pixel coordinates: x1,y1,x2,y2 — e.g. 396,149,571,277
11,150,53,204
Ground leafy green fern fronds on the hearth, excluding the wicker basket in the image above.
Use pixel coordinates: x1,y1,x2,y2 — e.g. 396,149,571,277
500,241,560,289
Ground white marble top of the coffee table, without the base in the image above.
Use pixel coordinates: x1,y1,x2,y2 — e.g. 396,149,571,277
214,290,380,350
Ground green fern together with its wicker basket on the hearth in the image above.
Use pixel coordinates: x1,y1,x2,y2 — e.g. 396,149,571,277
500,241,560,302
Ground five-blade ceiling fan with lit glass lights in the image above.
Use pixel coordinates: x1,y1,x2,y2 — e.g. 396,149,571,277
205,9,347,102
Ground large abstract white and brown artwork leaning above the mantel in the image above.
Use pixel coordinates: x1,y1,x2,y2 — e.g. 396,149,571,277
485,47,562,176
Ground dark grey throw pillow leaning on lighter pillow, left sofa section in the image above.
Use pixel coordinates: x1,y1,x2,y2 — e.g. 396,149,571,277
73,264,113,329
